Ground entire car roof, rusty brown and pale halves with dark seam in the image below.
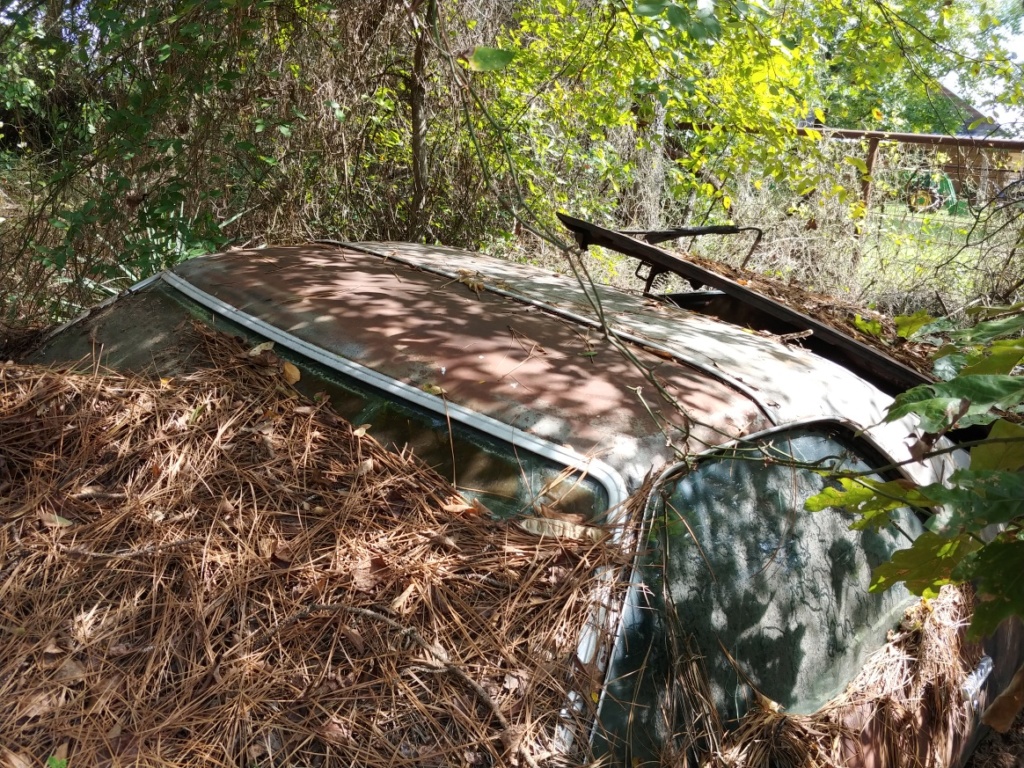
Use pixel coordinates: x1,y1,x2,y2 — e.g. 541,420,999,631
161,242,950,486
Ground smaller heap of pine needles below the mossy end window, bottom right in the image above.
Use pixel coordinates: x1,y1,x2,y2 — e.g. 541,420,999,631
702,587,982,768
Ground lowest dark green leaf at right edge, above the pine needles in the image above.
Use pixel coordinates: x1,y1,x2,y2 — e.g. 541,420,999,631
952,540,1024,639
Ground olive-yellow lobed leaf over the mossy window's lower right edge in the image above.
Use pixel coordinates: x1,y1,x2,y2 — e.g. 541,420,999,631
870,530,980,597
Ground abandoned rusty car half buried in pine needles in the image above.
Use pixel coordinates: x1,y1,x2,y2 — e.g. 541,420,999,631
19,218,1020,768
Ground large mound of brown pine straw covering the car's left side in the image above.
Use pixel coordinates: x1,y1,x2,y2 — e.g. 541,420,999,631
0,332,622,768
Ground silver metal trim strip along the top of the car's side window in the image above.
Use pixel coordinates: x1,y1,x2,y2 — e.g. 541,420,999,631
160,271,629,512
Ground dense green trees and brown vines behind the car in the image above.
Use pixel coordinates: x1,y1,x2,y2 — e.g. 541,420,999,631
0,0,1024,322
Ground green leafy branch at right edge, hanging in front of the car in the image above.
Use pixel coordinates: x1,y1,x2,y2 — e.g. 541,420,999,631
807,305,1024,636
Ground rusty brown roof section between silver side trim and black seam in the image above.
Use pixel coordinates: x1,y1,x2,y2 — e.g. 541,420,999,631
175,246,770,475
